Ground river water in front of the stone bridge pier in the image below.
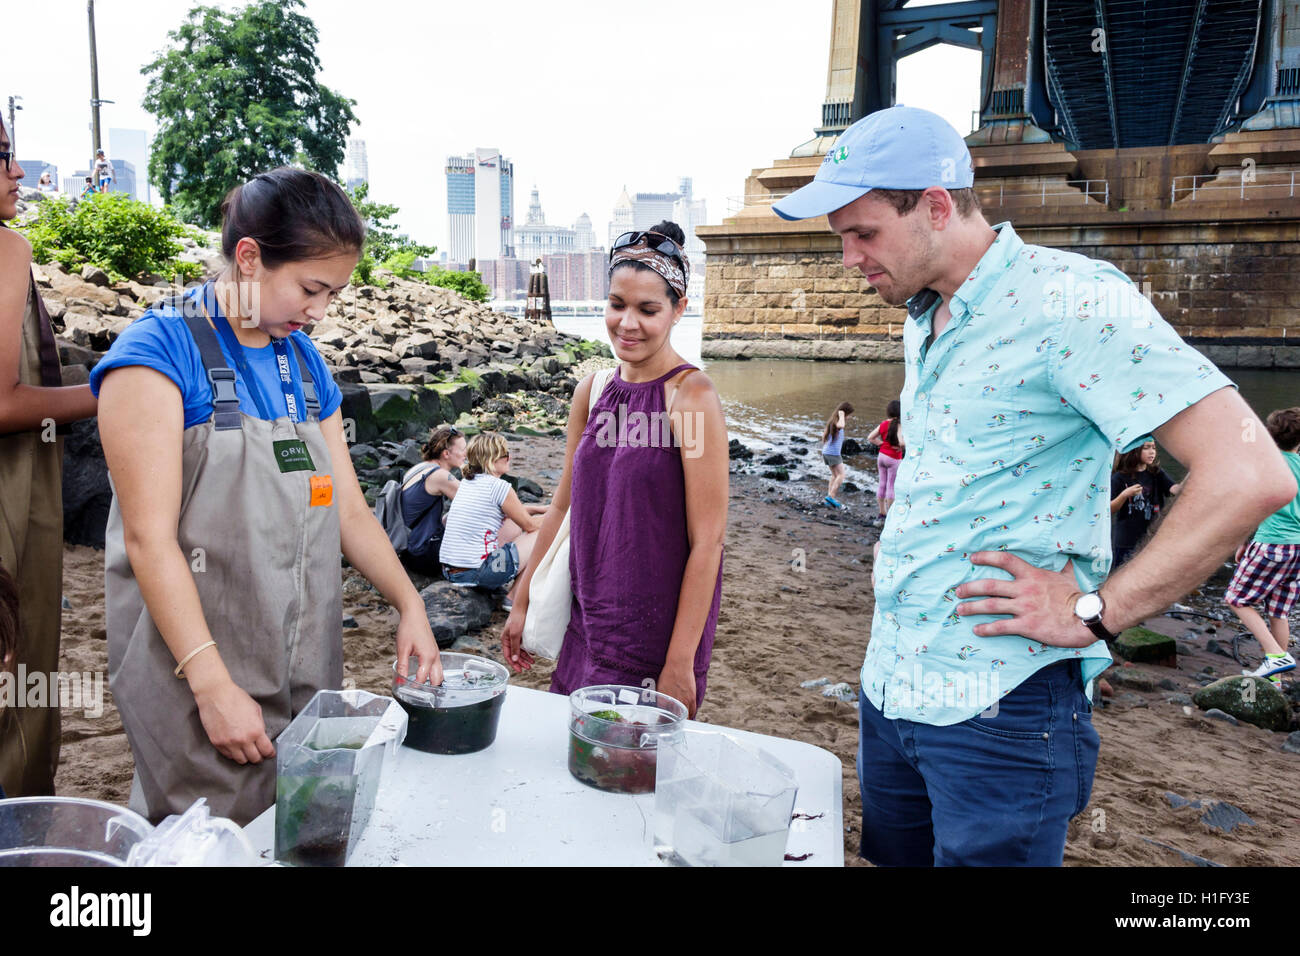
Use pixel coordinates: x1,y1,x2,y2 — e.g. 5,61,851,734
556,316,1300,489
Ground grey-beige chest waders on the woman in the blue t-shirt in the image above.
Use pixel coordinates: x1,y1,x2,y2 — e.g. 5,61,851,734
104,307,343,826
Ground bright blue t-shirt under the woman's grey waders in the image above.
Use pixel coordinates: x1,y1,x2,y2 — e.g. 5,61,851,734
90,295,343,428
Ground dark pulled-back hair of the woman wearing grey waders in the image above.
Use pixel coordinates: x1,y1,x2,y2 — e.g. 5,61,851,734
221,166,365,269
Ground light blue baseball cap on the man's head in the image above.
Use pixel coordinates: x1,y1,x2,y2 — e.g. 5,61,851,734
772,107,975,219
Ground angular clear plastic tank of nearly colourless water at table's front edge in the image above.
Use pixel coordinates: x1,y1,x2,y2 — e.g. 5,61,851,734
654,731,798,866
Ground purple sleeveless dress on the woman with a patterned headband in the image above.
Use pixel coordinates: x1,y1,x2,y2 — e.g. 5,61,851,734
551,365,723,706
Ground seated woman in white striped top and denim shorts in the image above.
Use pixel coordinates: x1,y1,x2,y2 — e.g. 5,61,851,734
438,432,546,606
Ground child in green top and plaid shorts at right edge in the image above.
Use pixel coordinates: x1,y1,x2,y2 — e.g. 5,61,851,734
1223,407,1300,684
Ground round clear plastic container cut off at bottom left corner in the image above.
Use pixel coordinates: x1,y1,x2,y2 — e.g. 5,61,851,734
0,797,153,866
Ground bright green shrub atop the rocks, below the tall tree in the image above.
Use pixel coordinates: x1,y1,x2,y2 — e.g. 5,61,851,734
22,193,203,282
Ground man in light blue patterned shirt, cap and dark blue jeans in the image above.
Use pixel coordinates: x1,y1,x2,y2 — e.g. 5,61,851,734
775,107,1295,865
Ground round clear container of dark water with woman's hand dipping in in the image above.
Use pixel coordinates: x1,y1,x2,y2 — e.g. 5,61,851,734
393,650,510,753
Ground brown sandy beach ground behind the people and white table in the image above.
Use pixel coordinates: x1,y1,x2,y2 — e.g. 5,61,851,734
50,438,1300,866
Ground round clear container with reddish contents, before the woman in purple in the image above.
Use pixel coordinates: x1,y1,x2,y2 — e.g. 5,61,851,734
568,684,686,793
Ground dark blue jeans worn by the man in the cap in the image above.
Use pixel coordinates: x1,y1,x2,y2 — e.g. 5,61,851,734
858,661,1101,866
